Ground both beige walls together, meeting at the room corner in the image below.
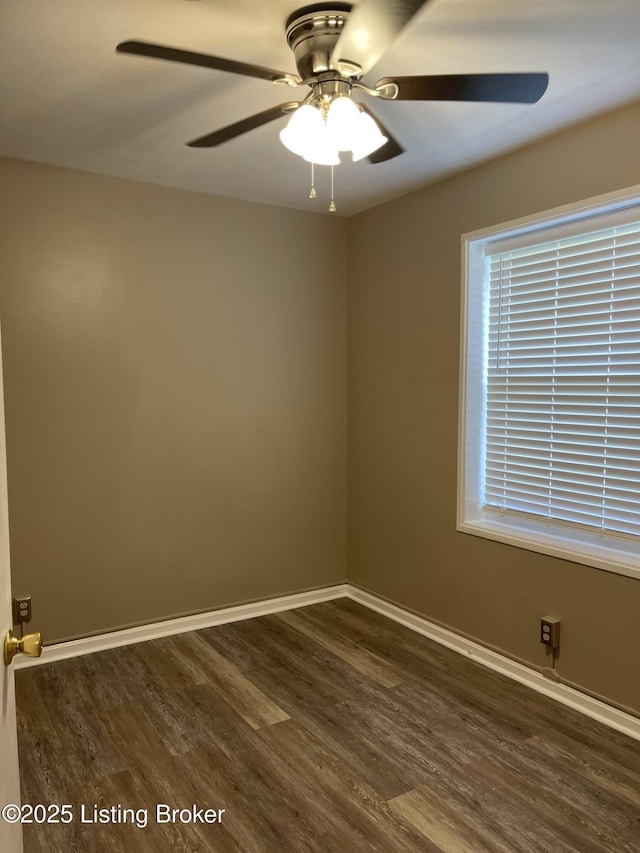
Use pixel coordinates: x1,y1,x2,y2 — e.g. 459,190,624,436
0,100,640,710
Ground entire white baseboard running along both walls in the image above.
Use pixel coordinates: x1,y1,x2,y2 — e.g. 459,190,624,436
14,583,640,740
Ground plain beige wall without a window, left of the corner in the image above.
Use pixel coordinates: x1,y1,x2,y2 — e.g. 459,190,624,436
0,160,347,641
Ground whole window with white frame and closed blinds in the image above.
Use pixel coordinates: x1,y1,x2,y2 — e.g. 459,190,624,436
458,188,640,578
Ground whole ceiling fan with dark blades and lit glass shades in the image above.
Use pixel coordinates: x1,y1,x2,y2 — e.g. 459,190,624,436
116,0,549,209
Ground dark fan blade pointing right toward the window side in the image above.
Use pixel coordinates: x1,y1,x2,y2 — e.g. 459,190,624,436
376,74,549,104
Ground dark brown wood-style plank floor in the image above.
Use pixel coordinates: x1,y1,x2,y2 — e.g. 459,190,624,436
17,599,640,853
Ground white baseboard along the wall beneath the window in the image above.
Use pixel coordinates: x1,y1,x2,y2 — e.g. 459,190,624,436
347,584,640,740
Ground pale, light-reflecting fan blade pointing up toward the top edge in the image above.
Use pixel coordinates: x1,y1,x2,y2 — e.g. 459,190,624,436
330,0,427,77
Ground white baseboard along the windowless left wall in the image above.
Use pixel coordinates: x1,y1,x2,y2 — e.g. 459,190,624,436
14,584,347,669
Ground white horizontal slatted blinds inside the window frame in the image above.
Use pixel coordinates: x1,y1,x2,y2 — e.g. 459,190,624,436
482,214,640,536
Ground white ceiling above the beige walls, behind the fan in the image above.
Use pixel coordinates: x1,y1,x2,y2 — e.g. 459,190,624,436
0,0,640,215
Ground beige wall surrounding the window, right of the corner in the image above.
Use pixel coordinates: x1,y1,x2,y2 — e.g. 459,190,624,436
348,100,640,710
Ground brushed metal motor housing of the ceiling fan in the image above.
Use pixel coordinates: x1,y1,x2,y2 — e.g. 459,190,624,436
285,3,353,83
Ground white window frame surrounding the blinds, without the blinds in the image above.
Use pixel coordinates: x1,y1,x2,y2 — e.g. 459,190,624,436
456,185,640,579
